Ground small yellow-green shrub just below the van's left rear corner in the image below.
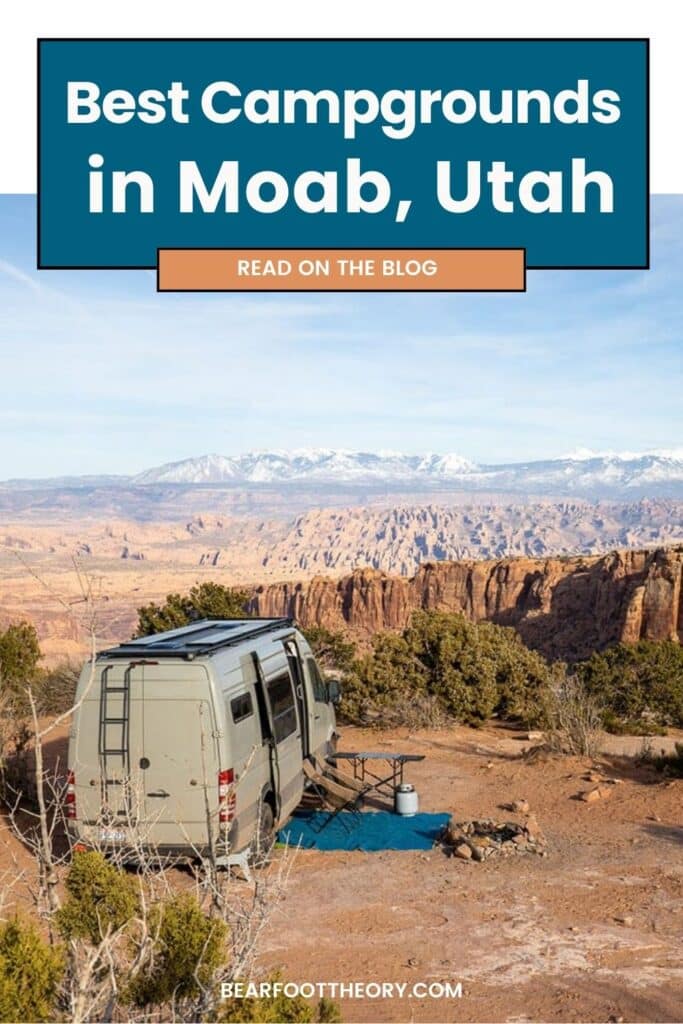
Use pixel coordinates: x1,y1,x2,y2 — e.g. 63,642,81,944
55,850,138,945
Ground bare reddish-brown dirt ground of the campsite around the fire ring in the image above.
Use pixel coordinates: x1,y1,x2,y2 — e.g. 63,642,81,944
0,727,683,1022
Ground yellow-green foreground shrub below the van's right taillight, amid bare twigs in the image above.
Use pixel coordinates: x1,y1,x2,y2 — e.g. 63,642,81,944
129,893,227,1007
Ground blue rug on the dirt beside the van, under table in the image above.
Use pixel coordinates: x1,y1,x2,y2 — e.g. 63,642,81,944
278,811,451,852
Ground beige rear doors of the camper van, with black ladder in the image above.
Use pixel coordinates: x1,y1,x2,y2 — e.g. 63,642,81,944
70,659,220,847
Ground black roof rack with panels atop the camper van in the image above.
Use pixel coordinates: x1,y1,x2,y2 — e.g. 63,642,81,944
97,618,294,660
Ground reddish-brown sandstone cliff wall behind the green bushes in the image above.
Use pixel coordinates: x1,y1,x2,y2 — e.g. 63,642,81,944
251,546,683,660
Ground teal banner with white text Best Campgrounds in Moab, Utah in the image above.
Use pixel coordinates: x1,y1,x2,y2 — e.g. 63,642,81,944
38,40,648,268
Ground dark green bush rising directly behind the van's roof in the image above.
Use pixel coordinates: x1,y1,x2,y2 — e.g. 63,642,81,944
135,583,249,637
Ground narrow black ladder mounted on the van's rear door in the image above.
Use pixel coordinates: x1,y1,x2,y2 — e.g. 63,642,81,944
97,665,131,816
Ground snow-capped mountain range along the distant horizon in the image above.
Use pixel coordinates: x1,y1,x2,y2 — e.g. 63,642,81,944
127,449,683,498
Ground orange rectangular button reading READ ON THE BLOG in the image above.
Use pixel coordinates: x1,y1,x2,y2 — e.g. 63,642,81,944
157,249,526,292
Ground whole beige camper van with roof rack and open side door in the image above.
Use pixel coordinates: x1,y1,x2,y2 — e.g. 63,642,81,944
66,618,337,857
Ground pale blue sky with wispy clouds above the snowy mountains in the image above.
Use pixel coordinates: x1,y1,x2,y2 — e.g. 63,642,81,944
0,196,683,479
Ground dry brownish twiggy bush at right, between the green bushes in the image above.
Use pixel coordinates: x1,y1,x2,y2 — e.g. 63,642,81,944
544,673,602,757
